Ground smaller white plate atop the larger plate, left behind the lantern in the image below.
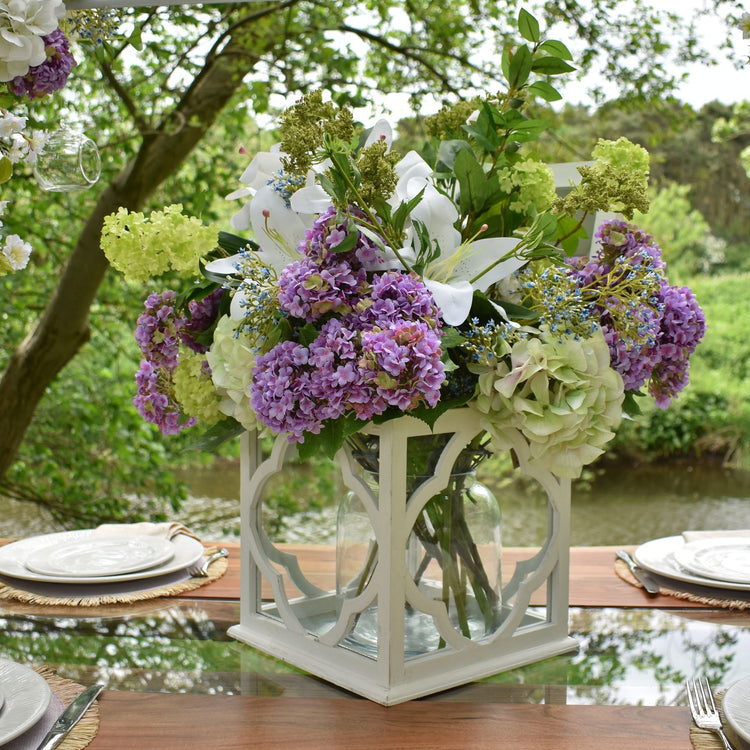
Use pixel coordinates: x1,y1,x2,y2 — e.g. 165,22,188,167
24,534,174,578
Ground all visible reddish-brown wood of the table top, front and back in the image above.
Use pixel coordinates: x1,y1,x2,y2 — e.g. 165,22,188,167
0,542,750,750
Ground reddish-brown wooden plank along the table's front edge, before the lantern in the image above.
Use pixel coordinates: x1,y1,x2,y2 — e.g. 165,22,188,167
88,691,692,750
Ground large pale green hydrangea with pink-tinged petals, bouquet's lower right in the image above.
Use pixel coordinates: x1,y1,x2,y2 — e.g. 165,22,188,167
473,330,624,479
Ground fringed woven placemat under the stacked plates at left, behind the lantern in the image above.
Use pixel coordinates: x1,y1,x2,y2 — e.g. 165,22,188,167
0,547,229,607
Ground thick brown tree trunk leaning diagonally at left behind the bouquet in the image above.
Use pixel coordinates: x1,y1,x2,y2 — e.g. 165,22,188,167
0,33,263,478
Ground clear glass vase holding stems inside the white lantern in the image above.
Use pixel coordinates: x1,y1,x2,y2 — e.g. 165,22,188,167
336,435,502,656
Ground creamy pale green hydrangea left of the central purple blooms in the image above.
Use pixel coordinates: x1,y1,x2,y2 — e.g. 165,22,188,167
206,315,262,430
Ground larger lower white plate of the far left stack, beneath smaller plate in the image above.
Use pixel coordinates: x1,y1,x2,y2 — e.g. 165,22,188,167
0,529,203,584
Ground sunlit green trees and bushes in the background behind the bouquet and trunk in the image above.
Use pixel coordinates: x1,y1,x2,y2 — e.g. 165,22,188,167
0,2,750,526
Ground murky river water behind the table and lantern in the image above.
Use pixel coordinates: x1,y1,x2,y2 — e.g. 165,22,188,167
0,463,750,546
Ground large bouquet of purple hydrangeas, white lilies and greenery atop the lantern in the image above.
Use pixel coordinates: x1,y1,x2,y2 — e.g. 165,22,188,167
102,11,705,477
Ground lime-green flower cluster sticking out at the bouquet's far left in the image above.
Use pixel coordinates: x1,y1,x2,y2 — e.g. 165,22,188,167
101,203,219,283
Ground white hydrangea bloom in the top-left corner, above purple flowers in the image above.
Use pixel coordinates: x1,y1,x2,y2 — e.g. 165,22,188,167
0,0,65,82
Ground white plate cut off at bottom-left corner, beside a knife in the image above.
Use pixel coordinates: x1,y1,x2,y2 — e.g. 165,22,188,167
0,659,52,745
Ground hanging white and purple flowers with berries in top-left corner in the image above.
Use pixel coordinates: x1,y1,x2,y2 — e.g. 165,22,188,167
0,0,117,99
